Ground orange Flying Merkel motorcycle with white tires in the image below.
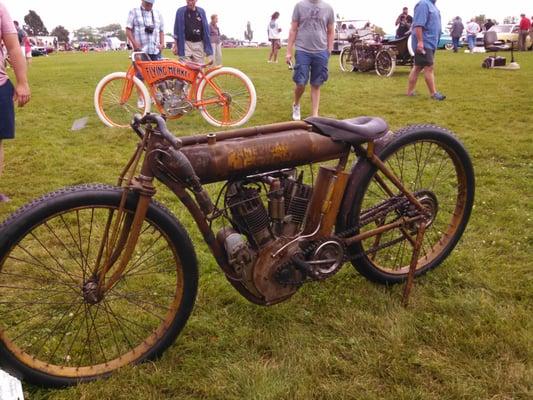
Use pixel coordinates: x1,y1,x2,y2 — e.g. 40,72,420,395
94,52,257,128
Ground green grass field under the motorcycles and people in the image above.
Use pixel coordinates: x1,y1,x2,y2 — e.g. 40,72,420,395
0,49,533,400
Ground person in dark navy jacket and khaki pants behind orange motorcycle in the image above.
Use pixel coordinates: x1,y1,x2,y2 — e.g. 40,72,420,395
174,0,213,63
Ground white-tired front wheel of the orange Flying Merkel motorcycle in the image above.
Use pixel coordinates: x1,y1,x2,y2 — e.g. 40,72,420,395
94,72,151,128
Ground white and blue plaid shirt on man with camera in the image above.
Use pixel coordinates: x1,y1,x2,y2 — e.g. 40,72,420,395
126,7,164,54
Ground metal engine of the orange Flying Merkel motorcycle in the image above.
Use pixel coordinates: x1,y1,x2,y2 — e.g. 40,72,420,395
154,79,194,117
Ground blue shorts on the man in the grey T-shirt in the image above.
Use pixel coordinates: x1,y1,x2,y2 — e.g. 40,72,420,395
292,50,329,86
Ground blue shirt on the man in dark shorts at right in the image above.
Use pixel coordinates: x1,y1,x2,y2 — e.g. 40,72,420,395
412,0,442,50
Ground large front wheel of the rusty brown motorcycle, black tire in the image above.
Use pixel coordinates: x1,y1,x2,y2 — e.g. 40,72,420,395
0,185,198,386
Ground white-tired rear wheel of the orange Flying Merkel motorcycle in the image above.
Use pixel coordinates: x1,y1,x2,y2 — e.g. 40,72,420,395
196,67,257,127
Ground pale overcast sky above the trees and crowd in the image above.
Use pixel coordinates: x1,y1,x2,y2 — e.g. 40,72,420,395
4,0,533,41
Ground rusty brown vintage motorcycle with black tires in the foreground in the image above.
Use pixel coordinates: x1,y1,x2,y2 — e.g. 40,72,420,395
0,114,474,386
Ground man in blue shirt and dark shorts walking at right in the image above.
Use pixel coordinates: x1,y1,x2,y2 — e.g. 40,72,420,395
407,0,446,100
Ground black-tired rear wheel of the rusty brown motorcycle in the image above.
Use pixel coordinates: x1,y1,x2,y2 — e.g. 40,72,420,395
342,126,474,283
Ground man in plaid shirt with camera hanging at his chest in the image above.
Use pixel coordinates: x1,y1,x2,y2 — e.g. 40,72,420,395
126,0,165,61
